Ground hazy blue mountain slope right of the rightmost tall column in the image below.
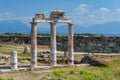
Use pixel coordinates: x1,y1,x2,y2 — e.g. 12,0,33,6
74,22,120,34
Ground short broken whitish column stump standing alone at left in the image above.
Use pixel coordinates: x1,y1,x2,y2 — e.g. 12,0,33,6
10,51,18,70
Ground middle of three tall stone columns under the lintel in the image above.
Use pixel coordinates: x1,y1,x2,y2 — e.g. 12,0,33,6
50,23,57,66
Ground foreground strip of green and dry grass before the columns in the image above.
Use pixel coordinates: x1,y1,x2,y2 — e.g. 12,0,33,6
0,60,120,80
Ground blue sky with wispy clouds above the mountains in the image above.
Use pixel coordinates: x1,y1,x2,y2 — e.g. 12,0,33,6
0,0,120,26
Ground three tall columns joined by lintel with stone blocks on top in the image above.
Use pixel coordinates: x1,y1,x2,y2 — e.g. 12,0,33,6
30,10,74,68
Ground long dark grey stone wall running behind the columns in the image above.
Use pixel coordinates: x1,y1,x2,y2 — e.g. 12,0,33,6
0,36,120,53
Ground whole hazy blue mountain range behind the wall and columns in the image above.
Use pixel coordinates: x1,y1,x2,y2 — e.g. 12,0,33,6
0,21,120,36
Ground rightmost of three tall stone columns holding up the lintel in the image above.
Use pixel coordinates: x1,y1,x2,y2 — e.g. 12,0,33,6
68,23,74,65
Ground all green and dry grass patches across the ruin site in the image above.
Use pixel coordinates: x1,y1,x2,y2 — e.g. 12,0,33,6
0,45,120,80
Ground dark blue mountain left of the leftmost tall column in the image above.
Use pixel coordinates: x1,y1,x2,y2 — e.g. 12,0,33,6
0,20,30,33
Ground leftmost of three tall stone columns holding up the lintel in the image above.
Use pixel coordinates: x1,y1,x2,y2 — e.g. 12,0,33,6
31,18,37,68
